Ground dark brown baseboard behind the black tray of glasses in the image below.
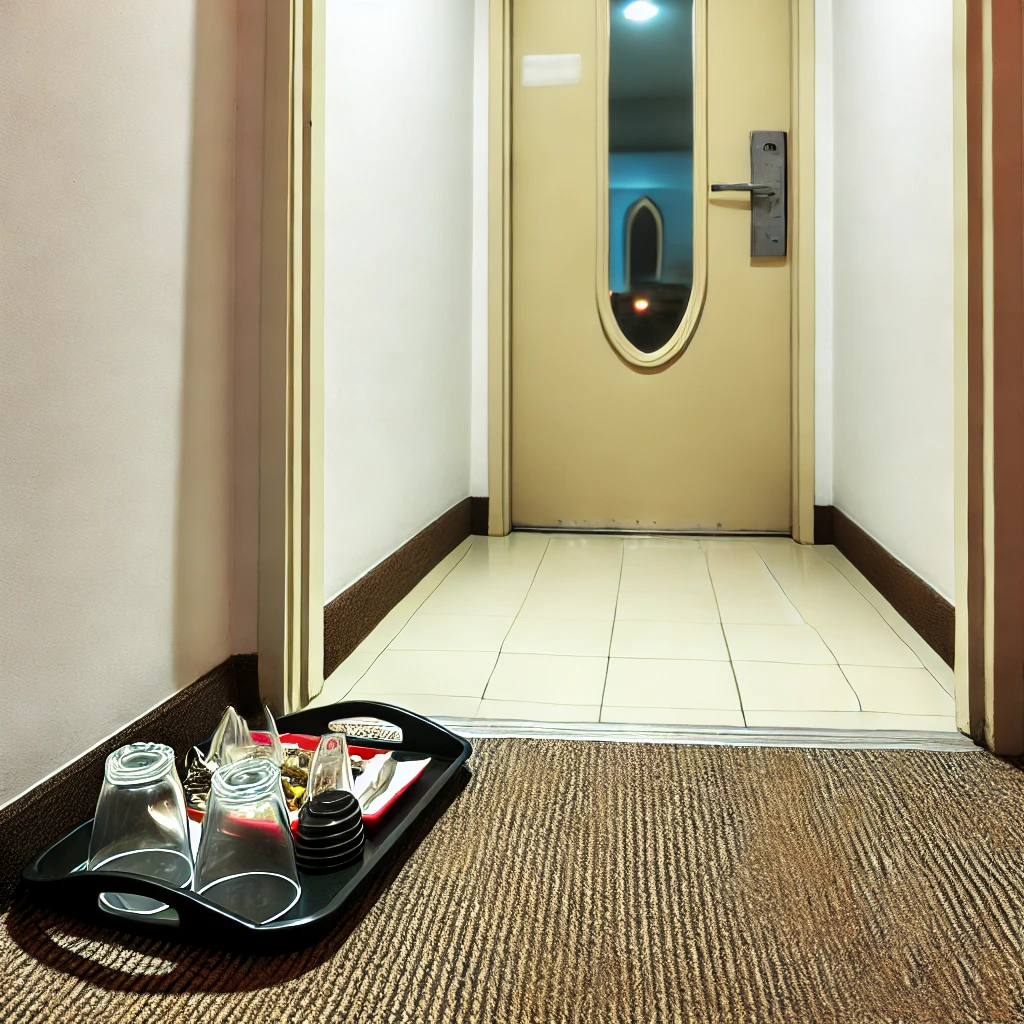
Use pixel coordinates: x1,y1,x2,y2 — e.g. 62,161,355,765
0,654,259,911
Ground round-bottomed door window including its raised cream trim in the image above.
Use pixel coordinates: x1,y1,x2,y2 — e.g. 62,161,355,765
597,0,707,367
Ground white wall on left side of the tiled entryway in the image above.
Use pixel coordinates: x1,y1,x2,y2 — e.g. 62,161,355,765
324,0,474,600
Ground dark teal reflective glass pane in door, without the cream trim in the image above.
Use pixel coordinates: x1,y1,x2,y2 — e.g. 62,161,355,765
608,0,693,352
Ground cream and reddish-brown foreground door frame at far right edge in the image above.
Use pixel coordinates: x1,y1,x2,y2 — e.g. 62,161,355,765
953,0,1024,755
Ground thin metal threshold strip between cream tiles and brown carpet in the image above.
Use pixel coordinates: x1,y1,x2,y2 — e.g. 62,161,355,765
436,717,982,753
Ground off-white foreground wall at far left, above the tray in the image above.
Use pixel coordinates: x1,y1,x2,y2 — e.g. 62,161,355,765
0,0,236,804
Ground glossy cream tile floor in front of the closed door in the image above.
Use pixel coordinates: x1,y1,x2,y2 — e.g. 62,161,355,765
314,534,955,732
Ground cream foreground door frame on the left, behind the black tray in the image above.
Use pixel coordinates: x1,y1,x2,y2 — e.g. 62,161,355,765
257,0,327,714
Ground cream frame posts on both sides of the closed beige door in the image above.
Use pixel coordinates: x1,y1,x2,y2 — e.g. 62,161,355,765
487,0,814,544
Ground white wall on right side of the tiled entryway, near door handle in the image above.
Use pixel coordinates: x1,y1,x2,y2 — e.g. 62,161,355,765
833,0,953,600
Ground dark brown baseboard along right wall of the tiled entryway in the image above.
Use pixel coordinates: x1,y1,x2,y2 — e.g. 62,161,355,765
814,506,956,668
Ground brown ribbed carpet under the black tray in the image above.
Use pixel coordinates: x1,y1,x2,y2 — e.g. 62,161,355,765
0,739,1024,1024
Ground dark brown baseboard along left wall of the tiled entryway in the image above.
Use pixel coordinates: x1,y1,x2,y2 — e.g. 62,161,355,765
324,498,475,677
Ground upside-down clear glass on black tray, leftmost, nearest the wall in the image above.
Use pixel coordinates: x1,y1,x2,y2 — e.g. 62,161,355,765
88,743,193,914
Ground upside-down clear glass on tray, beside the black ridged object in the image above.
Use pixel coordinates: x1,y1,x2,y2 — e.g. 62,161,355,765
196,758,301,925
